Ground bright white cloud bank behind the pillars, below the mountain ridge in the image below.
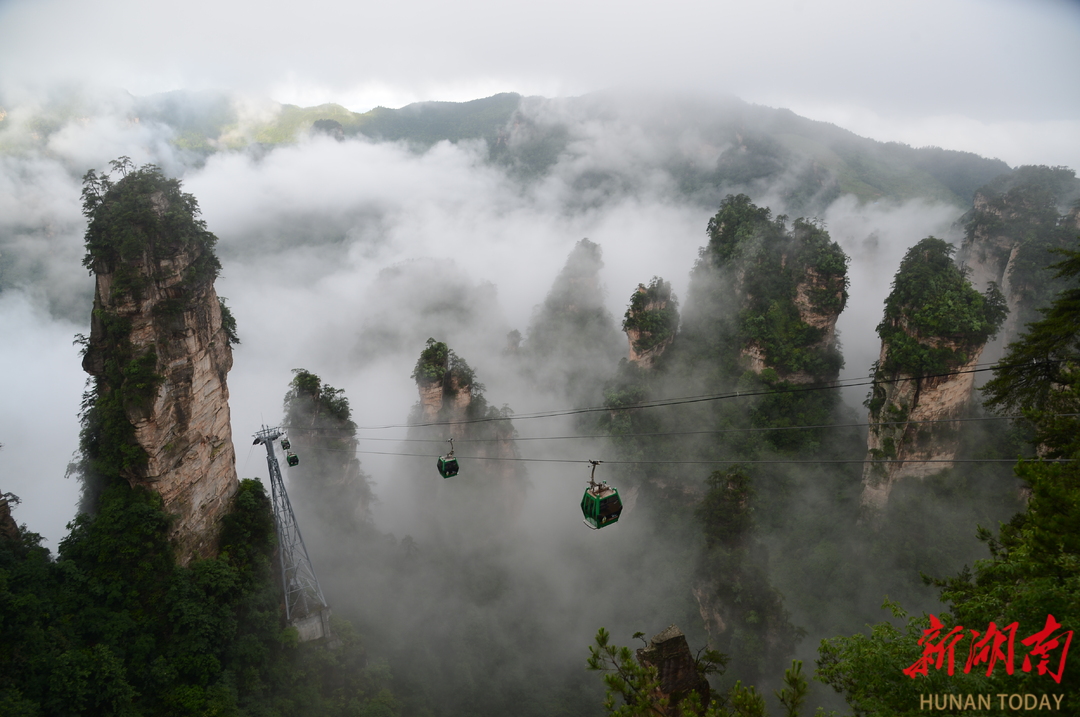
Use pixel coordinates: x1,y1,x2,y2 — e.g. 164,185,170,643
0,93,993,542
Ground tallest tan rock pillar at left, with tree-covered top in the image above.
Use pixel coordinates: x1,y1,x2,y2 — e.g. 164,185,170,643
83,168,238,564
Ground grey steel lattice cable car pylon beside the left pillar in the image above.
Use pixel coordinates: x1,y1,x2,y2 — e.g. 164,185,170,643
252,425,334,644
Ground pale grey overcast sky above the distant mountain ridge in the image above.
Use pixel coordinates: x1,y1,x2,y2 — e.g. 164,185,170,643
0,0,1080,167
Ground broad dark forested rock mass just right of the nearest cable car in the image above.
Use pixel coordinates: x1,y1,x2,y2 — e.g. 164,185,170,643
599,195,859,684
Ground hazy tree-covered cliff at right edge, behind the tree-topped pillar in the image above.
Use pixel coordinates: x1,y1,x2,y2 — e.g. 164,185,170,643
959,166,1080,360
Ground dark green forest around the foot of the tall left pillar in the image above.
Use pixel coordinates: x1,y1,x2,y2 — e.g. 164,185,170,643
0,481,396,717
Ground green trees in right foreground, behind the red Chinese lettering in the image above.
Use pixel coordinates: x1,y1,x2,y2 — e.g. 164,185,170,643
818,244,1080,716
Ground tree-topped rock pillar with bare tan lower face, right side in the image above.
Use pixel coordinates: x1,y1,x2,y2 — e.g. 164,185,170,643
862,236,1005,513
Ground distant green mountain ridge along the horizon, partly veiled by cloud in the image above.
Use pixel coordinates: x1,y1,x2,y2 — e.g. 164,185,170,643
0,86,1010,213
